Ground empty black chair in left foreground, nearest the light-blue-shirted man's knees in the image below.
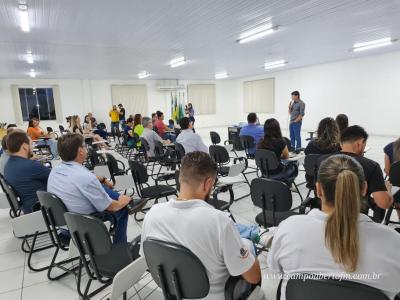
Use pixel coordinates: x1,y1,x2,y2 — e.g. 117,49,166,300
64,212,139,299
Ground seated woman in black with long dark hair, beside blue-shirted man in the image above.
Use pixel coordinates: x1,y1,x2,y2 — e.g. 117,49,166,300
257,118,298,178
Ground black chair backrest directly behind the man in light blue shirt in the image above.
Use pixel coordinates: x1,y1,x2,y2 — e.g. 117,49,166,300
36,191,68,228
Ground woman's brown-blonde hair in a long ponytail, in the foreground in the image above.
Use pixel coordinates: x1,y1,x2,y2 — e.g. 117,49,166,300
318,154,365,273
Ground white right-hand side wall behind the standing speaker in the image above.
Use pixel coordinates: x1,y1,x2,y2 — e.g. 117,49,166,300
239,52,400,136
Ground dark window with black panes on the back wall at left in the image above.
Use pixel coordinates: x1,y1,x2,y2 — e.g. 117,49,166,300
18,88,56,121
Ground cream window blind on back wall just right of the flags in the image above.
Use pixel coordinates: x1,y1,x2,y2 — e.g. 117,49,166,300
187,84,216,115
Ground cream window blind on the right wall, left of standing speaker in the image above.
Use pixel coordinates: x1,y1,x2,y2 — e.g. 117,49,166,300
243,78,275,113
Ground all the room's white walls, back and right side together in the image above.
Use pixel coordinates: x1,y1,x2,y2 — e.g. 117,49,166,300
0,52,400,135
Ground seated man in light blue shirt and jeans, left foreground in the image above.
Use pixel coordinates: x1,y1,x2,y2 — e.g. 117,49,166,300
47,133,131,244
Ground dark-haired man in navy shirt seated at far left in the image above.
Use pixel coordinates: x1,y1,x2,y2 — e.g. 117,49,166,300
4,129,50,214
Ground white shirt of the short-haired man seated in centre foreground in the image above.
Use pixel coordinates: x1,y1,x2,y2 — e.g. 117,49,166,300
140,200,255,300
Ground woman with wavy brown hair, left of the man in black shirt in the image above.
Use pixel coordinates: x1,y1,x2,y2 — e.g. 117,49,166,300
304,118,340,155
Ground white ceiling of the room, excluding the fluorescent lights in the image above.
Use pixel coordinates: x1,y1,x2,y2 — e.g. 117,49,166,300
0,0,400,79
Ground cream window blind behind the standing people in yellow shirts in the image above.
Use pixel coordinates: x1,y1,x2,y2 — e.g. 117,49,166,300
111,84,148,117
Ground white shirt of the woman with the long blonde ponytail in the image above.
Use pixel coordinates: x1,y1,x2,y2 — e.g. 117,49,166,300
268,209,400,300
